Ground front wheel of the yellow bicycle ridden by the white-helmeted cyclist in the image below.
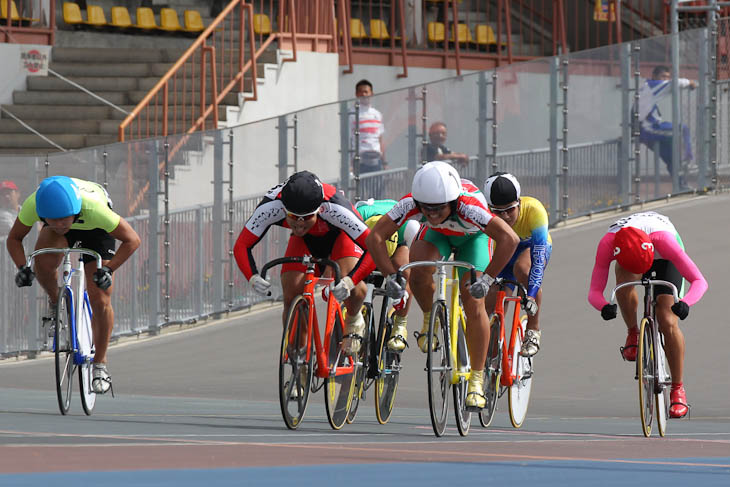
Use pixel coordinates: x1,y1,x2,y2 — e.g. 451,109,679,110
426,301,451,436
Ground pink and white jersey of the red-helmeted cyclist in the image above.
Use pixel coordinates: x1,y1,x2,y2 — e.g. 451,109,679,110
588,211,707,311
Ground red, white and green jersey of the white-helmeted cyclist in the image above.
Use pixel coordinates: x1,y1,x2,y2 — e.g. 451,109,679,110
387,179,494,236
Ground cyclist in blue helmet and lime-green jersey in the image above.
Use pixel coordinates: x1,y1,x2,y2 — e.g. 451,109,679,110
7,176,140,394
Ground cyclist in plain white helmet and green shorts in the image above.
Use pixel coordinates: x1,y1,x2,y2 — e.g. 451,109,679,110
366,161,519,408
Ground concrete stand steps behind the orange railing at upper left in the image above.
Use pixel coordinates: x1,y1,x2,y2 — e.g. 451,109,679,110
0,0,264,154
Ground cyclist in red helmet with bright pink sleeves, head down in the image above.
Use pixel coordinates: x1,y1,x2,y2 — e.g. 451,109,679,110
588,211,707,418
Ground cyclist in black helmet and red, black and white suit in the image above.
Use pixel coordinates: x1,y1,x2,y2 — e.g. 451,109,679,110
233,171,375,354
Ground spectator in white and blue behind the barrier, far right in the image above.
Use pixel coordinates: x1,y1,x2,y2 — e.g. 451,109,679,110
639,66,697,184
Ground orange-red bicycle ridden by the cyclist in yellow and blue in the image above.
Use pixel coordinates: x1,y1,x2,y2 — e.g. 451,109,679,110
479,277,533,428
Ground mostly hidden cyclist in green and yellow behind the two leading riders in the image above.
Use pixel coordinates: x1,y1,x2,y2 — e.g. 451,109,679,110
355,198,421,352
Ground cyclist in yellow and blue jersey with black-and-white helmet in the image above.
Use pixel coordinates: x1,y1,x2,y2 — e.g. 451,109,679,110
484,172,553,357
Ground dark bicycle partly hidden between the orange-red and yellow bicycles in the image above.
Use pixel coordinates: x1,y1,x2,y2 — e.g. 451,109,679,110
347,271,401,424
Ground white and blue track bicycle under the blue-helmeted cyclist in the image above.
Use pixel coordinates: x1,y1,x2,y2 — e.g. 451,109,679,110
26,248,102,415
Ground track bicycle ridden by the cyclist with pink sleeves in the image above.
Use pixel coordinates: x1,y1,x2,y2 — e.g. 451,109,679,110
611,278,679,438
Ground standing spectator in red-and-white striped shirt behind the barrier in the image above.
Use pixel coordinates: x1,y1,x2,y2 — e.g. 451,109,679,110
350,79,388,199
